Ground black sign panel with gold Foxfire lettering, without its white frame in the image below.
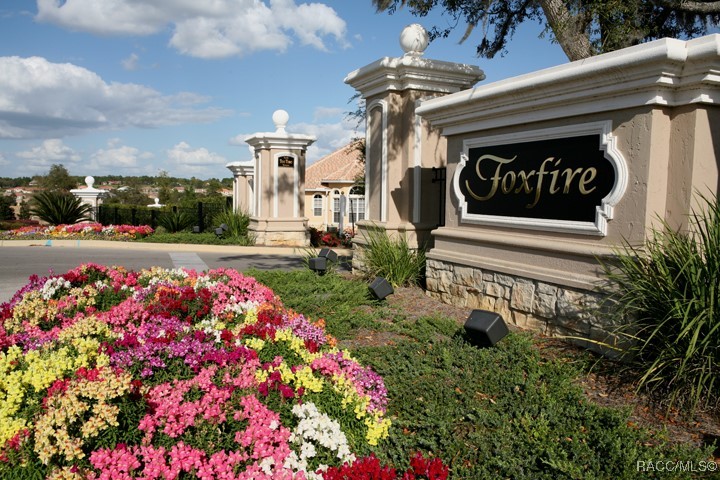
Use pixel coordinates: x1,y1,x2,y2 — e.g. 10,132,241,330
458,135,615,222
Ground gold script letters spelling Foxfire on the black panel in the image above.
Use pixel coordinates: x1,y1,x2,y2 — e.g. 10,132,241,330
465,154,597,208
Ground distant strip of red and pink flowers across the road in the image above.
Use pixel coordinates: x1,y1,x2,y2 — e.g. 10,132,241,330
0,223,153,240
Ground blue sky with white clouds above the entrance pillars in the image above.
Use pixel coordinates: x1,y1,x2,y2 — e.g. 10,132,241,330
0,0,566,179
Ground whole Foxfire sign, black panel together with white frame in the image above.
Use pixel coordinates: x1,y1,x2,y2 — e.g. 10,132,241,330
454,124,626,235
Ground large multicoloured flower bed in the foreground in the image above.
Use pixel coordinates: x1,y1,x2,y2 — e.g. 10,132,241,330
0,264,447,479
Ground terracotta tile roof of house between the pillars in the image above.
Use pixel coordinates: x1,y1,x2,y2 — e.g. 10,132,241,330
305,141,365,190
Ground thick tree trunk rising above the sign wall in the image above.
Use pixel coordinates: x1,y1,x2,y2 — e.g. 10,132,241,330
538,0,595,62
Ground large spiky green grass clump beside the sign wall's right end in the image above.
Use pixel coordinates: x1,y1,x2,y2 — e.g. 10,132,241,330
604,191,720,411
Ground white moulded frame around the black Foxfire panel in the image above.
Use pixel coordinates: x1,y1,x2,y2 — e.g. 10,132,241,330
453,120,629,236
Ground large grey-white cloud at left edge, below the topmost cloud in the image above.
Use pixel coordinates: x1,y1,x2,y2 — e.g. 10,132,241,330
0,57,230,138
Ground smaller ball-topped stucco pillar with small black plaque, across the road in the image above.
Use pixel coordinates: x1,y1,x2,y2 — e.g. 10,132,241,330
245,110,315,247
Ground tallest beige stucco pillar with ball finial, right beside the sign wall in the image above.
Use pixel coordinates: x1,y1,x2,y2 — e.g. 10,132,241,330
345,24,485,247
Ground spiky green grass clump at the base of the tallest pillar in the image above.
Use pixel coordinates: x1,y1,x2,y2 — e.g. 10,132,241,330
358,228,425,287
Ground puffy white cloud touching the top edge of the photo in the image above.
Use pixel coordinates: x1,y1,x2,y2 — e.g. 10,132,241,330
36,0,348,58
